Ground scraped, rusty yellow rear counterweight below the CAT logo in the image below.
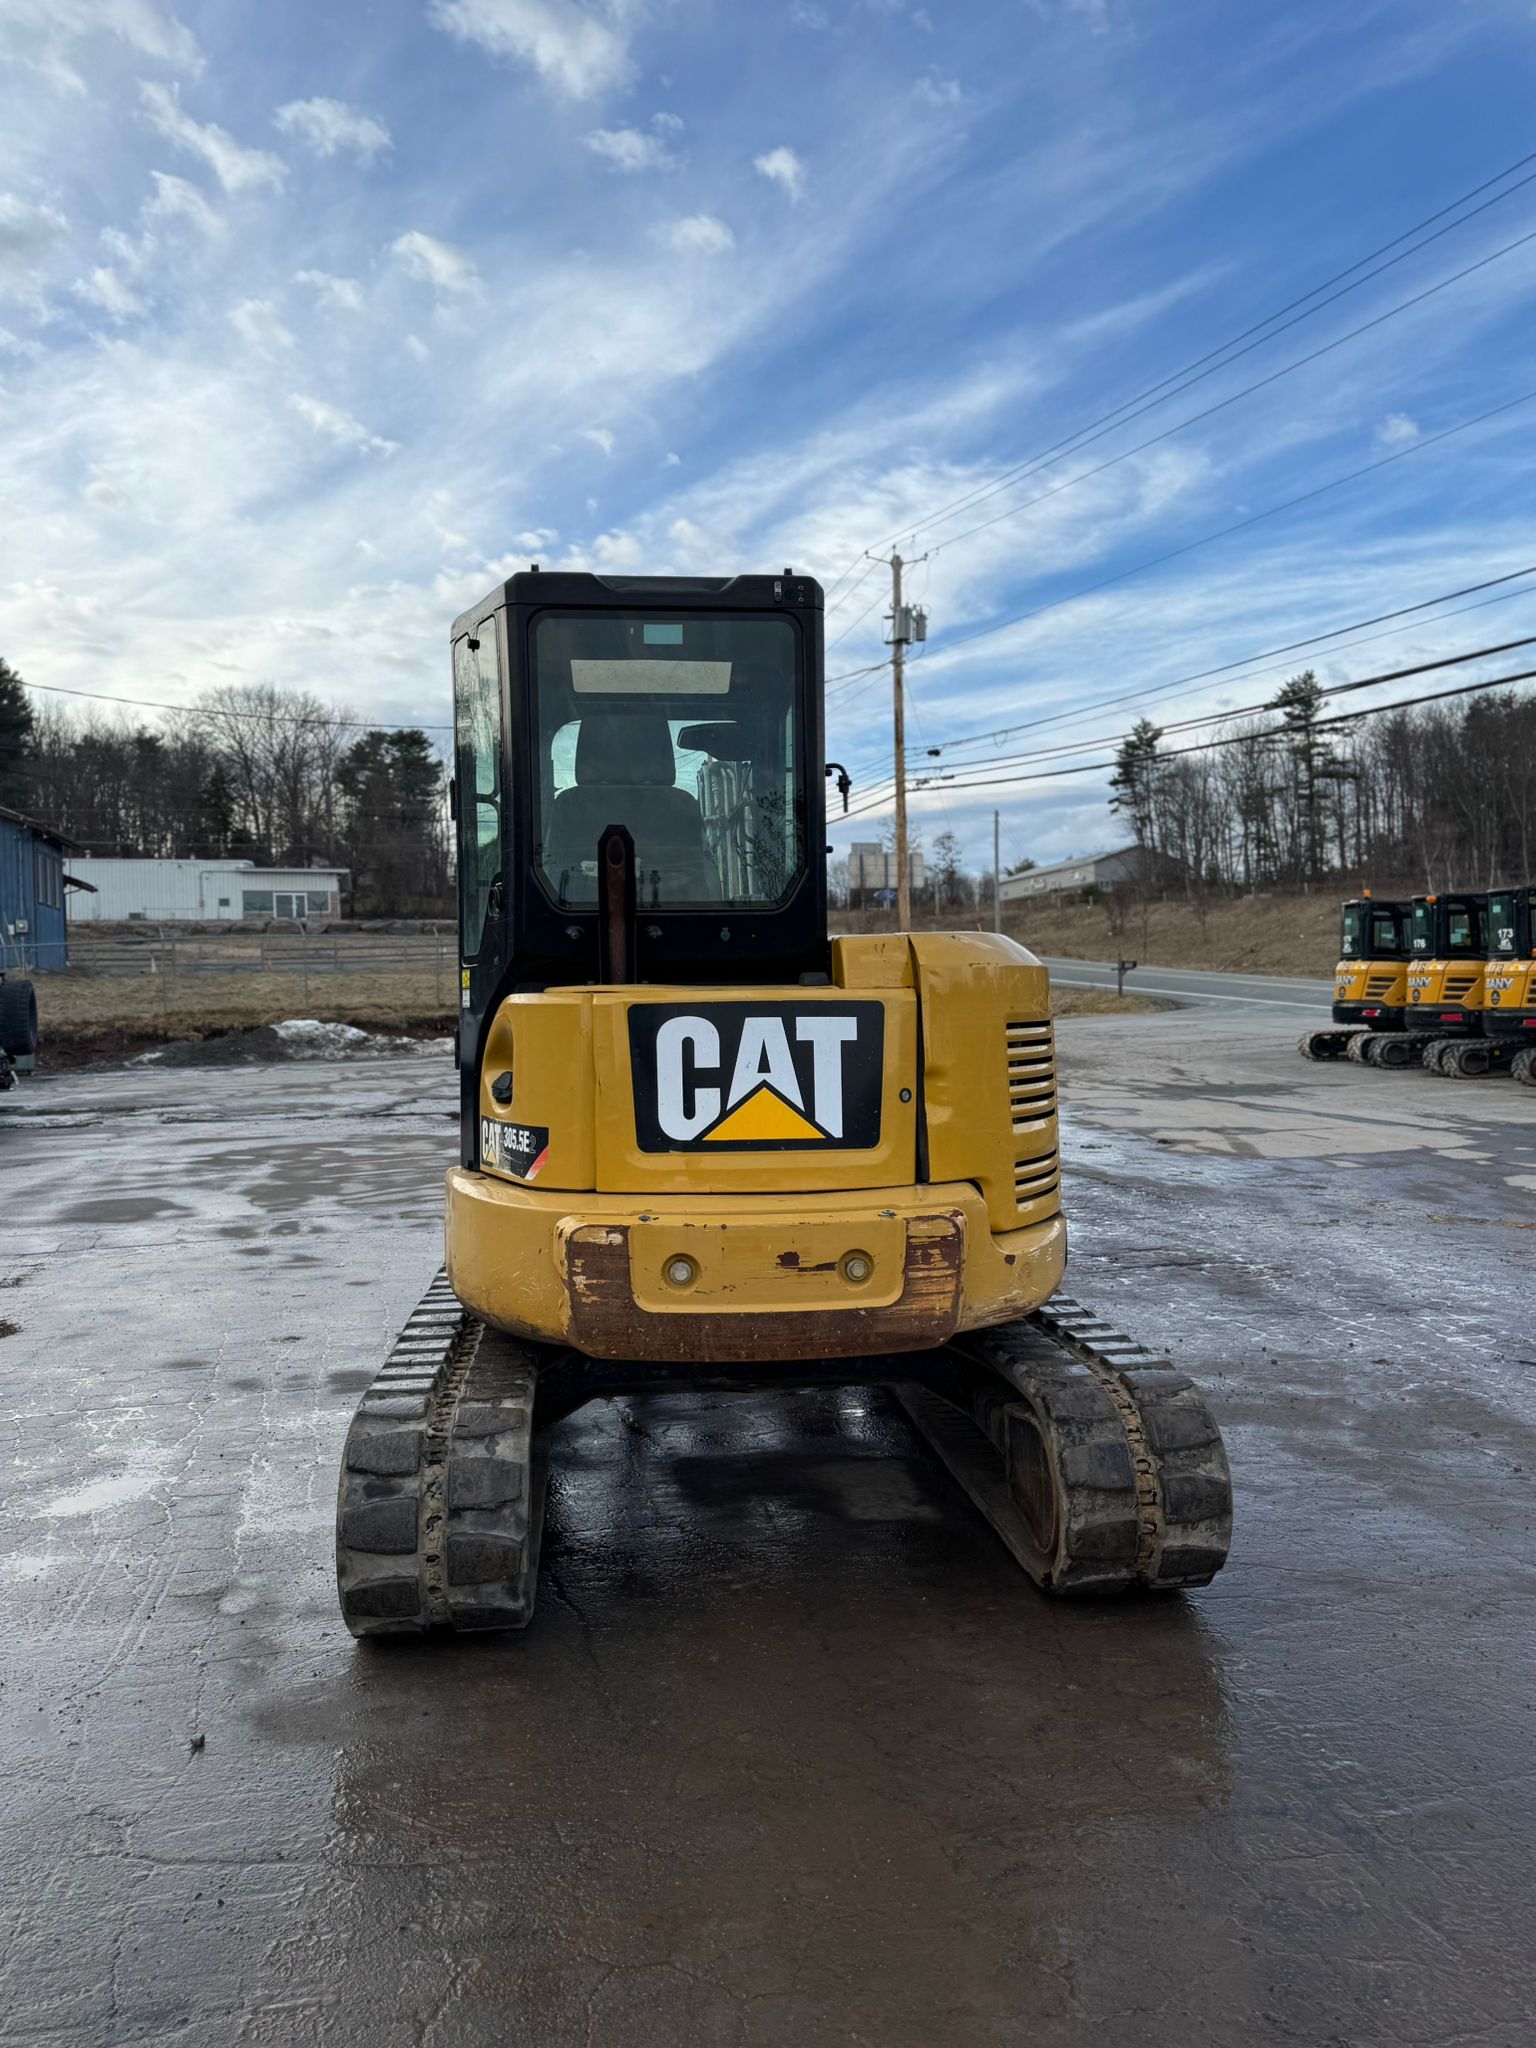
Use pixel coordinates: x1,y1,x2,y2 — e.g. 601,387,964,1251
446,1167,1067,1364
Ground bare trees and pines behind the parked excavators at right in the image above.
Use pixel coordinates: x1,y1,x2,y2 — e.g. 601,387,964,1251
1110,670,1536,889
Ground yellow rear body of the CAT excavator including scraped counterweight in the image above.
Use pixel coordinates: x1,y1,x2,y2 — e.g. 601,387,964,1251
446,934,1067,1364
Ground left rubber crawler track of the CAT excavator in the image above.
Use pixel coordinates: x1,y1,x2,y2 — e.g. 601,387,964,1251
336,1274,545,1636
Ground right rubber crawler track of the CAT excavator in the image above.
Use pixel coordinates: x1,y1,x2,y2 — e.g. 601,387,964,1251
897,1296,1233,1593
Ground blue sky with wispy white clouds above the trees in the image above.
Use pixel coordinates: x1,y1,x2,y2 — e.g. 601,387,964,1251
0,0,1536,866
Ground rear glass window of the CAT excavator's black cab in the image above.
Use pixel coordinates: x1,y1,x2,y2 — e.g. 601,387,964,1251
532,612,805,909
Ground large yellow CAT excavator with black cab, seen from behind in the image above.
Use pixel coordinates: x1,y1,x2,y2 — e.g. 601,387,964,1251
336,569,1231,1636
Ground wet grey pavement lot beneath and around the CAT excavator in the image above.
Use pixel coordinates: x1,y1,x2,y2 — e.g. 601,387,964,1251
0,1012,1536,2048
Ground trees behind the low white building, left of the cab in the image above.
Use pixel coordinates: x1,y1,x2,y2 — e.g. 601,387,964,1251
0,664,453,918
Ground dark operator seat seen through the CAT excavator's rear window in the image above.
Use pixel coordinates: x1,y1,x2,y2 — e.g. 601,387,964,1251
543,711,721,909
